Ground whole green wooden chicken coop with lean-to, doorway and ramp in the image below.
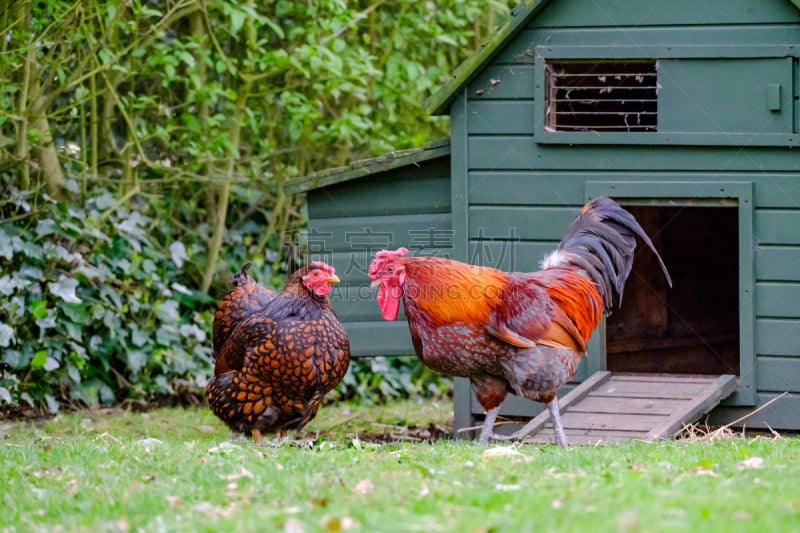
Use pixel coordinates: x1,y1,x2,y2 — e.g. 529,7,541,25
289,0,800,442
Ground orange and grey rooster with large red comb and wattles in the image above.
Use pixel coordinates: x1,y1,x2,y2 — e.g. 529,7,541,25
369,197,672,447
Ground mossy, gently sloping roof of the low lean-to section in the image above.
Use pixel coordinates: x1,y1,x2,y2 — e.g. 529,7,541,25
285,138,450,194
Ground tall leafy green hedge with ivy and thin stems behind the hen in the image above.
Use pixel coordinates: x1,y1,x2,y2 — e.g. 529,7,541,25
0,0,506,412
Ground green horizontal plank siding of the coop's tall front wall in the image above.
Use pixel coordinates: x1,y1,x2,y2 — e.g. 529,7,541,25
451,0,800,429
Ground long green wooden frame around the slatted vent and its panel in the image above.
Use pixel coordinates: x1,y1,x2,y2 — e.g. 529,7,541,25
533,44,800,146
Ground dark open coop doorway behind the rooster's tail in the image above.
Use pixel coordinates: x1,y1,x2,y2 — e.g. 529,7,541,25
606,204,741,376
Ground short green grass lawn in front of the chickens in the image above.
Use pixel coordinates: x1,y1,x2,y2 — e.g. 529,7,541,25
0,402,800,533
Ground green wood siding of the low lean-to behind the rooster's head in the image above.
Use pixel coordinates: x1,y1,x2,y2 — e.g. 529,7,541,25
308,157,453,356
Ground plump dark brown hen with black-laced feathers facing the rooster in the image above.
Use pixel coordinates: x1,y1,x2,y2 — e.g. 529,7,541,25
206,261,350,441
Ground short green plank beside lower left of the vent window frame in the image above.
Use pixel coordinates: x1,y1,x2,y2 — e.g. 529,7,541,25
467,100,533,135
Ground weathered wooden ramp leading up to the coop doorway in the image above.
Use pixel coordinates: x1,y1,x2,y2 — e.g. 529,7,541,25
512,372,736,445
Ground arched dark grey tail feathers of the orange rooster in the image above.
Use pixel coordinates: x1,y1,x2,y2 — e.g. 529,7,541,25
542,196,672,314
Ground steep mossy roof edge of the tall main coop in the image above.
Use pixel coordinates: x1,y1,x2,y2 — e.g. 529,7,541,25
424,0,800,115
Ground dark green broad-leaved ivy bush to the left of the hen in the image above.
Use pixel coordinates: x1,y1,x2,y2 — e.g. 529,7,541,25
0,183,212,413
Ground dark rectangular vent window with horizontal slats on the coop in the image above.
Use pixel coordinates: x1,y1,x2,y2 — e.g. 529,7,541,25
545,60,658,132
